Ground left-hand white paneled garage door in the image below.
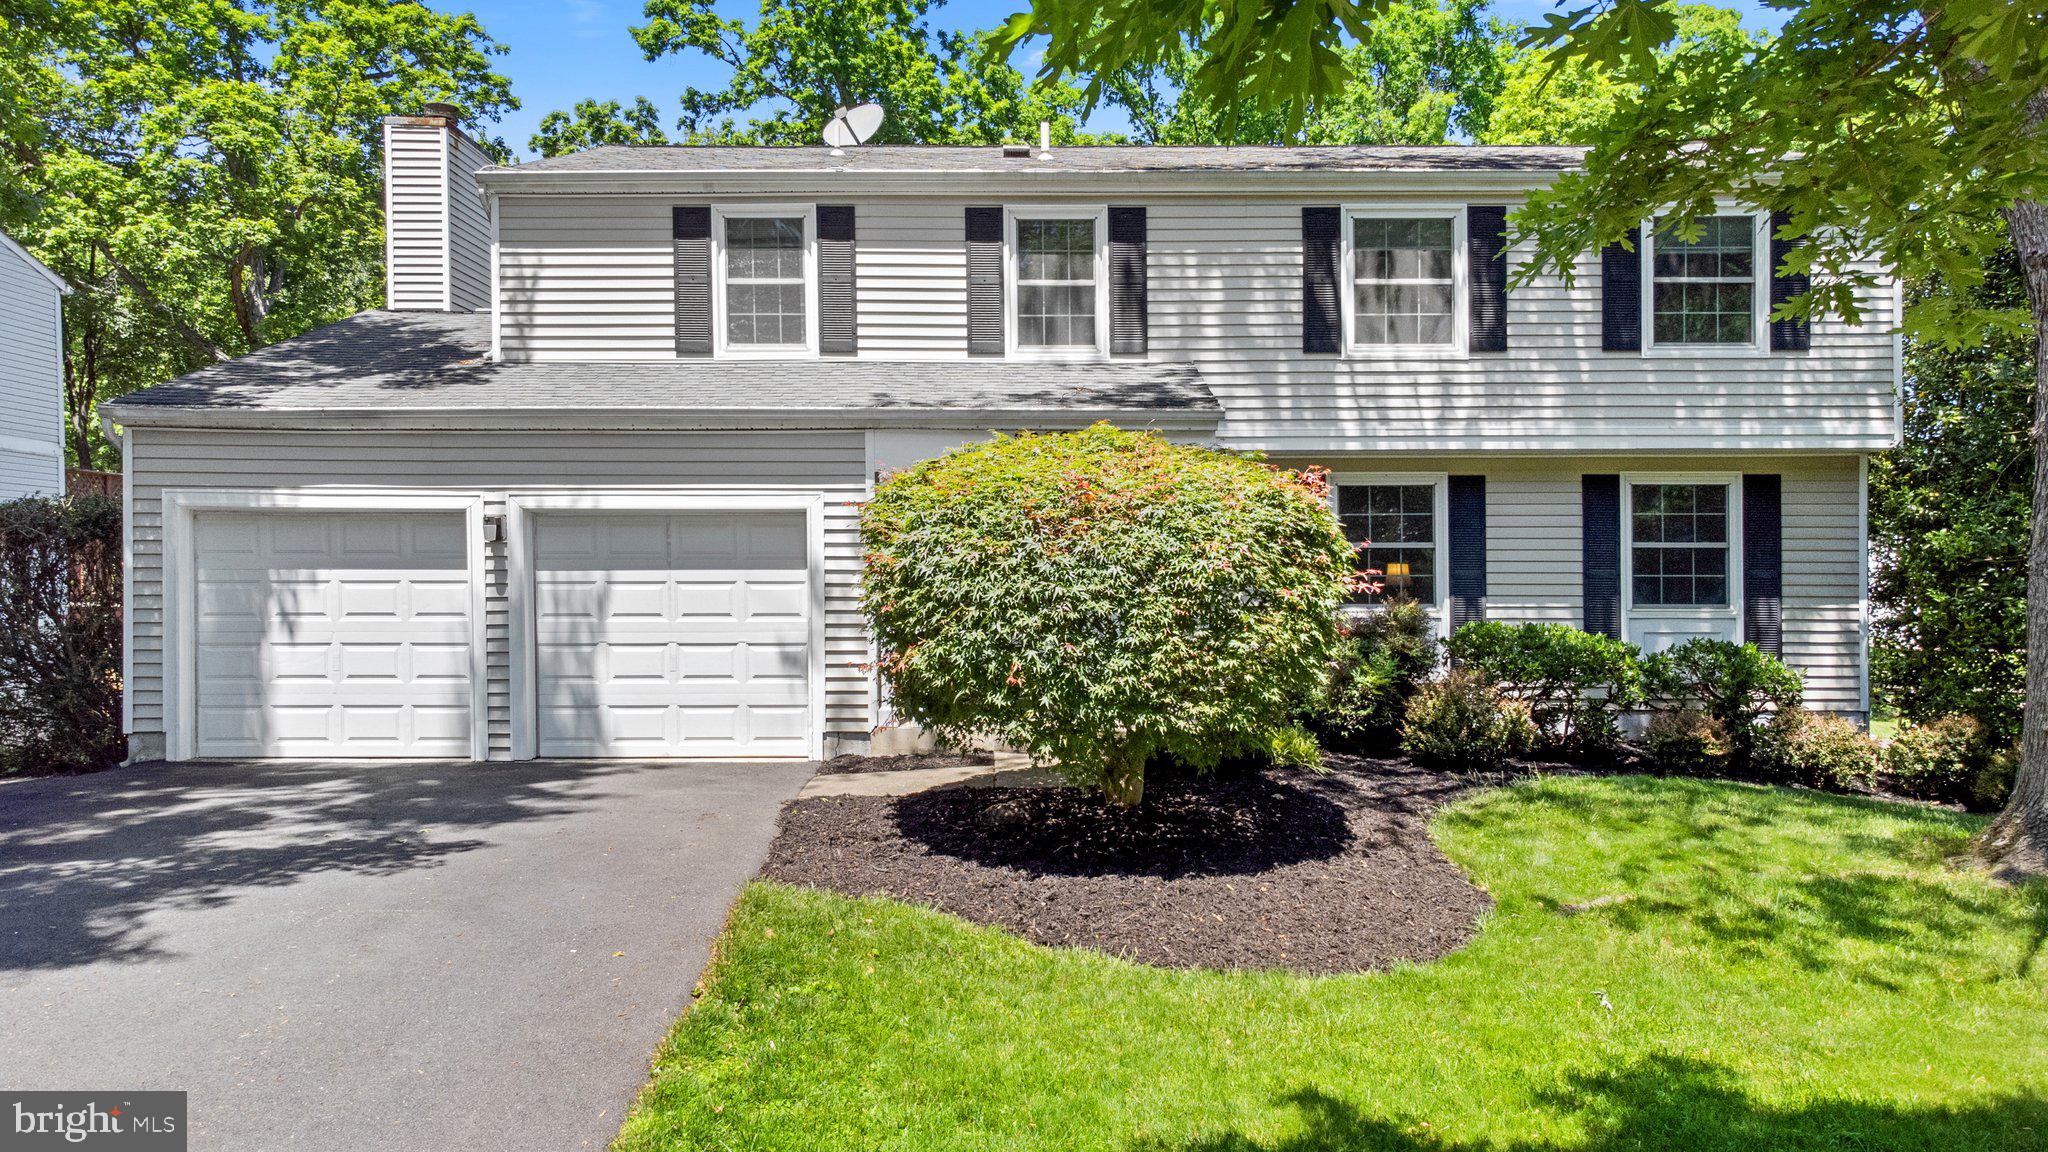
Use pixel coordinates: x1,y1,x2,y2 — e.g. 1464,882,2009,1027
195,512,471,758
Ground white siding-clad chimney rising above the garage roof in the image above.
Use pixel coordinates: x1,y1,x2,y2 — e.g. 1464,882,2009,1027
385,105,492,312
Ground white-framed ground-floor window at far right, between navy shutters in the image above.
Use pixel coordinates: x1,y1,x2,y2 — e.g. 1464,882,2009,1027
1628,484,1729,607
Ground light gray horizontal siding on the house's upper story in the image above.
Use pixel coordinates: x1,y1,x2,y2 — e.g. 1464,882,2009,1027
487,190,1896,451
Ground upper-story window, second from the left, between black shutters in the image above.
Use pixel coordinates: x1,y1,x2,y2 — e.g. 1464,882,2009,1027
1010,209,1108,357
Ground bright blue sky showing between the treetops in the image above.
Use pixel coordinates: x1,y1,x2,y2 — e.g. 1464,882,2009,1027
460,0,1782,156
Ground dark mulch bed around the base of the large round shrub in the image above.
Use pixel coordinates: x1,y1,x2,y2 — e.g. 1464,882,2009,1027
764,756,1491,974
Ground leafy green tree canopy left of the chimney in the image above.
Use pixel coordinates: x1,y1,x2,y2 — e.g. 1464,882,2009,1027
0,0,514,465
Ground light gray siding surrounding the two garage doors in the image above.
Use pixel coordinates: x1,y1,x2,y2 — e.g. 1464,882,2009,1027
127,428,872,758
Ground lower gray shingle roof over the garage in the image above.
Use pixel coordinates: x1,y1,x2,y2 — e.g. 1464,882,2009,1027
106,312,1219,422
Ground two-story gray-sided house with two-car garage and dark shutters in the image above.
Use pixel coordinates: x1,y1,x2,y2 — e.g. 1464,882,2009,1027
92,115,1898,758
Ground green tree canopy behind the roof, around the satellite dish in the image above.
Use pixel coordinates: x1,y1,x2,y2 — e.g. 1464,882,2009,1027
633,0,1083,143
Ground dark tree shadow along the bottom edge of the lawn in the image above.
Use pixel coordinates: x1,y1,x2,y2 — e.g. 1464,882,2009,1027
1130,1054,2048,1152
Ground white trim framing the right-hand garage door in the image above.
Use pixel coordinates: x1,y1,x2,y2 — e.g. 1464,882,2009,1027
506,488,825,760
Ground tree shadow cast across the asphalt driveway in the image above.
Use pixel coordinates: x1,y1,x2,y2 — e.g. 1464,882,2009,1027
0,760,616,972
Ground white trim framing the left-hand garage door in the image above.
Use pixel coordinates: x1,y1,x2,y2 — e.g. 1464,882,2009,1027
164,488,489,760
